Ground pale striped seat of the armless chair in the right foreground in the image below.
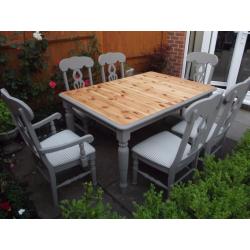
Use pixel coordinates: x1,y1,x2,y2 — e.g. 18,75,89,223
132,131,191,168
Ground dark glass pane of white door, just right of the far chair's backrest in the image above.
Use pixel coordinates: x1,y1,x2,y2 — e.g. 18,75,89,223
212,31,237,82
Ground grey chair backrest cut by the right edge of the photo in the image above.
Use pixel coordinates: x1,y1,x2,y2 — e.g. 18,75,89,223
212,77,250,144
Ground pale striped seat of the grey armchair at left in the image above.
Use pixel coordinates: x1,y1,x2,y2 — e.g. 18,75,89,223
41,130,95,167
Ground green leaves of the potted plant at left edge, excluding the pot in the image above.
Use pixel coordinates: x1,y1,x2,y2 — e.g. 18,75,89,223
0,100,15,133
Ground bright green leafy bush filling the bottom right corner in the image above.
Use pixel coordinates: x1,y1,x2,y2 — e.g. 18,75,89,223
134,131,250,218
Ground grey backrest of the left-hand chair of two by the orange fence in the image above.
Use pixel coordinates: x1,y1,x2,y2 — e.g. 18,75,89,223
59,56,94,90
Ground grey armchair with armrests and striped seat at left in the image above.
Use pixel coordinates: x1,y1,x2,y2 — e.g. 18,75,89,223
1,89,96,207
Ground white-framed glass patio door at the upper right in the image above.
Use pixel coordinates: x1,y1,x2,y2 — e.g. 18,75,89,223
202,31,250,105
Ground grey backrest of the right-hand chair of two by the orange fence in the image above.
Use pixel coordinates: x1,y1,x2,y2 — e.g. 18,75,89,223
98,52,126,82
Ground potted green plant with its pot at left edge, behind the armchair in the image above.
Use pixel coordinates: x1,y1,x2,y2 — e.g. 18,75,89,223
0,100,18,142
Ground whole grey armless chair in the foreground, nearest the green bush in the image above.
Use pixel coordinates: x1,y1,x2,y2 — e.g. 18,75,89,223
132,94,222,193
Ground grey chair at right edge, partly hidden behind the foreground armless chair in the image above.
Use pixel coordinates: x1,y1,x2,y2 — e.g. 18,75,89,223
171,77,250,154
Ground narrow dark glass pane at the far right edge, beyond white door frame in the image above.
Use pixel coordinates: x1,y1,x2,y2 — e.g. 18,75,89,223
237,32,250,82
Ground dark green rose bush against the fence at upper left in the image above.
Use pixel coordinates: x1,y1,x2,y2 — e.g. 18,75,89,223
1,32,48,101
